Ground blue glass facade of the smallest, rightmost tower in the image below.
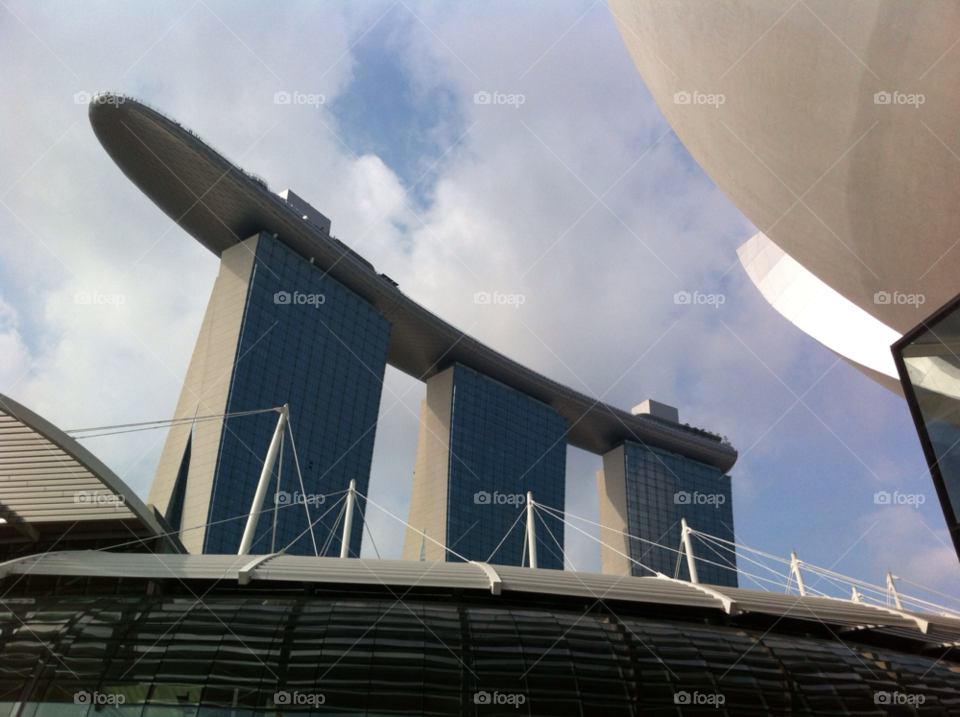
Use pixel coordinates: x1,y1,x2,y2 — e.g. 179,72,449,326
624,441,737,587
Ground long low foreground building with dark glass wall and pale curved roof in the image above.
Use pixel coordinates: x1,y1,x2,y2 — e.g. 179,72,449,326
0,553,960,717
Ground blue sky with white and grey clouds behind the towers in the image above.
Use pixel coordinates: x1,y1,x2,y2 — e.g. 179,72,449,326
0,0,960,594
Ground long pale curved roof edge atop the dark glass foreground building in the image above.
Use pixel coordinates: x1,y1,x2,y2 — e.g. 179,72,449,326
0,551,960,649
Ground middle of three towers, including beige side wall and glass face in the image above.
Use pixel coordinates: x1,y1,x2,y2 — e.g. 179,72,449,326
404,364,567,570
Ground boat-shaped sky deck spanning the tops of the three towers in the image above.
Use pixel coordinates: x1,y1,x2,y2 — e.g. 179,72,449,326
89,94,737,472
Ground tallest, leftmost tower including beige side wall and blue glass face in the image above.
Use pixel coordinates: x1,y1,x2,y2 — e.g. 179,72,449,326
154,232,391,555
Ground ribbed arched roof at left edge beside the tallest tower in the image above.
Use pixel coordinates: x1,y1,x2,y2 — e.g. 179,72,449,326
0,394,172,541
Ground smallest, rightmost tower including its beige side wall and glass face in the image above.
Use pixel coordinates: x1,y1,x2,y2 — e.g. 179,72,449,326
598,441,737,587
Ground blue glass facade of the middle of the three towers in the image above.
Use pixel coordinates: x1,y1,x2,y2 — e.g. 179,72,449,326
447,364,567,570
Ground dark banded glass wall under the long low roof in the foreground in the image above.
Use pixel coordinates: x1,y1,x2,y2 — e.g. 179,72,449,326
0,577,960,717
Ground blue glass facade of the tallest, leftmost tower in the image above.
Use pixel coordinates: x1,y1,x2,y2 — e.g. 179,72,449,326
204,233,390,555
